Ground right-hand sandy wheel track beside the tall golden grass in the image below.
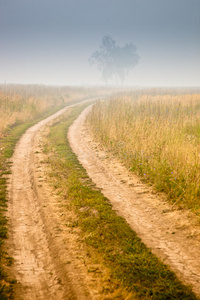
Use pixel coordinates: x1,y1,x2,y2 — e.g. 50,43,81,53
68,104,200,295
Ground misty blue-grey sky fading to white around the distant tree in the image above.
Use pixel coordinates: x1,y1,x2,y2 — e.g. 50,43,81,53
0,0,200,87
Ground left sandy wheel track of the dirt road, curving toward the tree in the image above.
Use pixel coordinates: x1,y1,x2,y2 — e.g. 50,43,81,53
8,100,97,300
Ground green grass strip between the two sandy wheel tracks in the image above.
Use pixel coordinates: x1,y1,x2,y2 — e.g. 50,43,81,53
45,102,197,300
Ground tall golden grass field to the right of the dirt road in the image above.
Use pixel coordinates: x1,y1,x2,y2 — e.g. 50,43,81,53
88,89,200,216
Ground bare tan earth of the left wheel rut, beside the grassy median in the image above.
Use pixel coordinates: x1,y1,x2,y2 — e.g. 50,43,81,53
7,101,106,300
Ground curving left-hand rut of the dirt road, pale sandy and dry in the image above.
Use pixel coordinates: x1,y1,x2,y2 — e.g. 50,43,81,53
8,99,95,300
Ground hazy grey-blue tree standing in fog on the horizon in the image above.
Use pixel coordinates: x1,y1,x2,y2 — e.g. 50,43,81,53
89,36,139,84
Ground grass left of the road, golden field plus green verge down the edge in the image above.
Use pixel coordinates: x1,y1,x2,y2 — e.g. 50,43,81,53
0,85,104,300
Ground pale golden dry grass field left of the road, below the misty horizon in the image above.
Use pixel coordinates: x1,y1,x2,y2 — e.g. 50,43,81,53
0,85,101,132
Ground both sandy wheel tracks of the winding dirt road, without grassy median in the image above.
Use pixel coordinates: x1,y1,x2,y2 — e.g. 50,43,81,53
8,100,200,300
